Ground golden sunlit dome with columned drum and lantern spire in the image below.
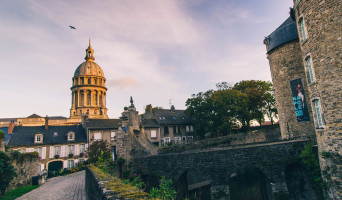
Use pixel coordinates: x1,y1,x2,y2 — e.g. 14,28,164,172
70,40,108,119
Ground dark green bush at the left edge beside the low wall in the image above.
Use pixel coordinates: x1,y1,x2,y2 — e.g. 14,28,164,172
0,152,16,196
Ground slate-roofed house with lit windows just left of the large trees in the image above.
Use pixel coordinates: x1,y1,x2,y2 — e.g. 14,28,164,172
142,105,194,146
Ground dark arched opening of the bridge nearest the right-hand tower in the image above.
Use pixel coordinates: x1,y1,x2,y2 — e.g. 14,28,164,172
285,163,318,200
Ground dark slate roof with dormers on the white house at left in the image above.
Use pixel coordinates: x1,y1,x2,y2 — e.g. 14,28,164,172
8,125,87,146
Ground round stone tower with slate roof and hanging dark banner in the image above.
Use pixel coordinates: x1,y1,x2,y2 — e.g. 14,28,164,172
264,17,315,139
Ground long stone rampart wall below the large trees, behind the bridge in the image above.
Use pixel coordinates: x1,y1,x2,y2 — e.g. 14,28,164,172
158,125,281,154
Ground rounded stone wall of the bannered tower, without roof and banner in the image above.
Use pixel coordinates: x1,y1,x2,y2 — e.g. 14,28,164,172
267,40,315,139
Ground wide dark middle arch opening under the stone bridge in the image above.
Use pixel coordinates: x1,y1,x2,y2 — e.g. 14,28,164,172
229,168,269,200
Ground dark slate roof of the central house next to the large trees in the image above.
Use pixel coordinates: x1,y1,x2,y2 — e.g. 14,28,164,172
153,109,193,125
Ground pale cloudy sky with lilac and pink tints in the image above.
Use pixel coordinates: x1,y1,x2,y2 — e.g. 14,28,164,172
0,0,292,118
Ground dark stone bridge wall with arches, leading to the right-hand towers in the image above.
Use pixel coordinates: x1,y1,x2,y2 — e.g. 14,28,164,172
133,139,309,199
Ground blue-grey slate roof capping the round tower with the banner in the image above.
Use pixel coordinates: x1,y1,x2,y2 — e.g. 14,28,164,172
266,17,298,53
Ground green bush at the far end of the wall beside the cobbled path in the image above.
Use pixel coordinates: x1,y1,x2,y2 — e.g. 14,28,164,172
88,140,112,163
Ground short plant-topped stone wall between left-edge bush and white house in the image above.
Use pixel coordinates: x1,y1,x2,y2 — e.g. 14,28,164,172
7,153,39,190
